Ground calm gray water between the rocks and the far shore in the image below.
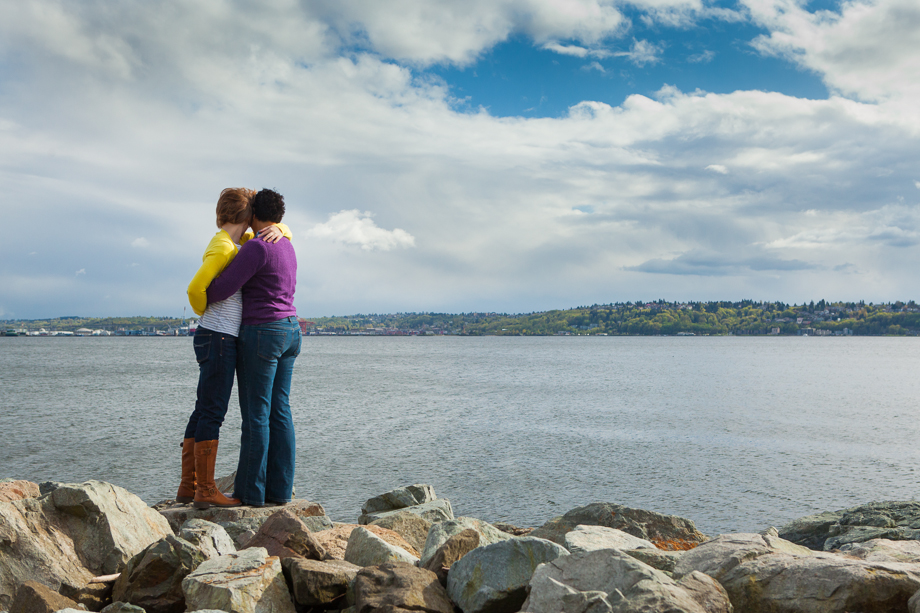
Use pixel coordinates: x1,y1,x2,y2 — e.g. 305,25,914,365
0,337,920,534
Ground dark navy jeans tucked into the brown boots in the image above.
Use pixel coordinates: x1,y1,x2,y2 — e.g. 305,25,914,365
185,326,236,442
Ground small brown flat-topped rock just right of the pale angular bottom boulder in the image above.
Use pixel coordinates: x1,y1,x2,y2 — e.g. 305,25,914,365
281,557,361,609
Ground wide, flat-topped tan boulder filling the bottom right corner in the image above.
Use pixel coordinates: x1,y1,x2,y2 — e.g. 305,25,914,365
716,552,920,613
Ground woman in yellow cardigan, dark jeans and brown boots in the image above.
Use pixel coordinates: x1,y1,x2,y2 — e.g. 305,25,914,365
176,188,291,509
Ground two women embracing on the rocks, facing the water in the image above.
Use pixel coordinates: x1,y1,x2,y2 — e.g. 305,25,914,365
176,188,300,509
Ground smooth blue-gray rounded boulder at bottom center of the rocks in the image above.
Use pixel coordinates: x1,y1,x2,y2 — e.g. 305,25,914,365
447,536,569,613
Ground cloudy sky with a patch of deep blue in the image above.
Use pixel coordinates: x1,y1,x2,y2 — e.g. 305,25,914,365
0,0,920,319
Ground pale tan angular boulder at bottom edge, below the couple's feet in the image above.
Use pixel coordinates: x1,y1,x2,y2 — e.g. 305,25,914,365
182,547,295,613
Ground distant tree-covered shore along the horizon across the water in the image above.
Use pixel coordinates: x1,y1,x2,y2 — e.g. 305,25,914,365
7,300,920,336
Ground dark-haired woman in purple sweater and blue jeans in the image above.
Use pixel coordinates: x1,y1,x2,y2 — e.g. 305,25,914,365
208,189,300,507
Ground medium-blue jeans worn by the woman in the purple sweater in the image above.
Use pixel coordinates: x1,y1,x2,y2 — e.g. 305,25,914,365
233,317,300,506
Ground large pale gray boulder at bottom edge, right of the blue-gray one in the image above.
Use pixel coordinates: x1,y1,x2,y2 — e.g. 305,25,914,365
523,549,732,613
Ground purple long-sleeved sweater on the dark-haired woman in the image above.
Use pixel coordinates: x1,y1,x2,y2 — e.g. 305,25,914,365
208,233,297,326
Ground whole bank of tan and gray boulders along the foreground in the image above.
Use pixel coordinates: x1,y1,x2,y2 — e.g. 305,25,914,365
0,480,920,613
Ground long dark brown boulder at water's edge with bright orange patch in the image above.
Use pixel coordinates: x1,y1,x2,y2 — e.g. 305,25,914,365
530,502,706,551
